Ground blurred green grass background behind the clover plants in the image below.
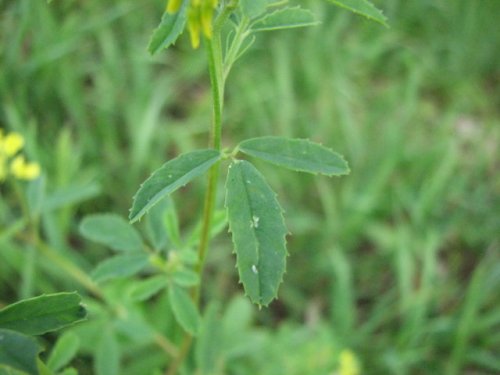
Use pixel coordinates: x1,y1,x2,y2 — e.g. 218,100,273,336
0,0,500,375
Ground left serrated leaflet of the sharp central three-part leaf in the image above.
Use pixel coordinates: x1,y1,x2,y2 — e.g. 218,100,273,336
129,150,221,223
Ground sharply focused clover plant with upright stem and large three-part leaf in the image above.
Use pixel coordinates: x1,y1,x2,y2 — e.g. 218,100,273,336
125,0,386,373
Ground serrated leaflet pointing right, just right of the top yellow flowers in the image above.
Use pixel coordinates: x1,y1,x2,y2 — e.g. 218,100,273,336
251,7,319,31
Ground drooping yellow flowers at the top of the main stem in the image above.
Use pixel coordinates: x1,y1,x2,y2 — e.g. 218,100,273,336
167,0,219,48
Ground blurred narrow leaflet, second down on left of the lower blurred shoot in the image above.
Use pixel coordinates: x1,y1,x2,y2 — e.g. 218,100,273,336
92,253,149,282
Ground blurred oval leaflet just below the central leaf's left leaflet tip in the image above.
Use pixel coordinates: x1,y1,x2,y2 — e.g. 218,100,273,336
80,214,143,252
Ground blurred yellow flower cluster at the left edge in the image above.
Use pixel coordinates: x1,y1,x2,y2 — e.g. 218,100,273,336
0,129,40,182
